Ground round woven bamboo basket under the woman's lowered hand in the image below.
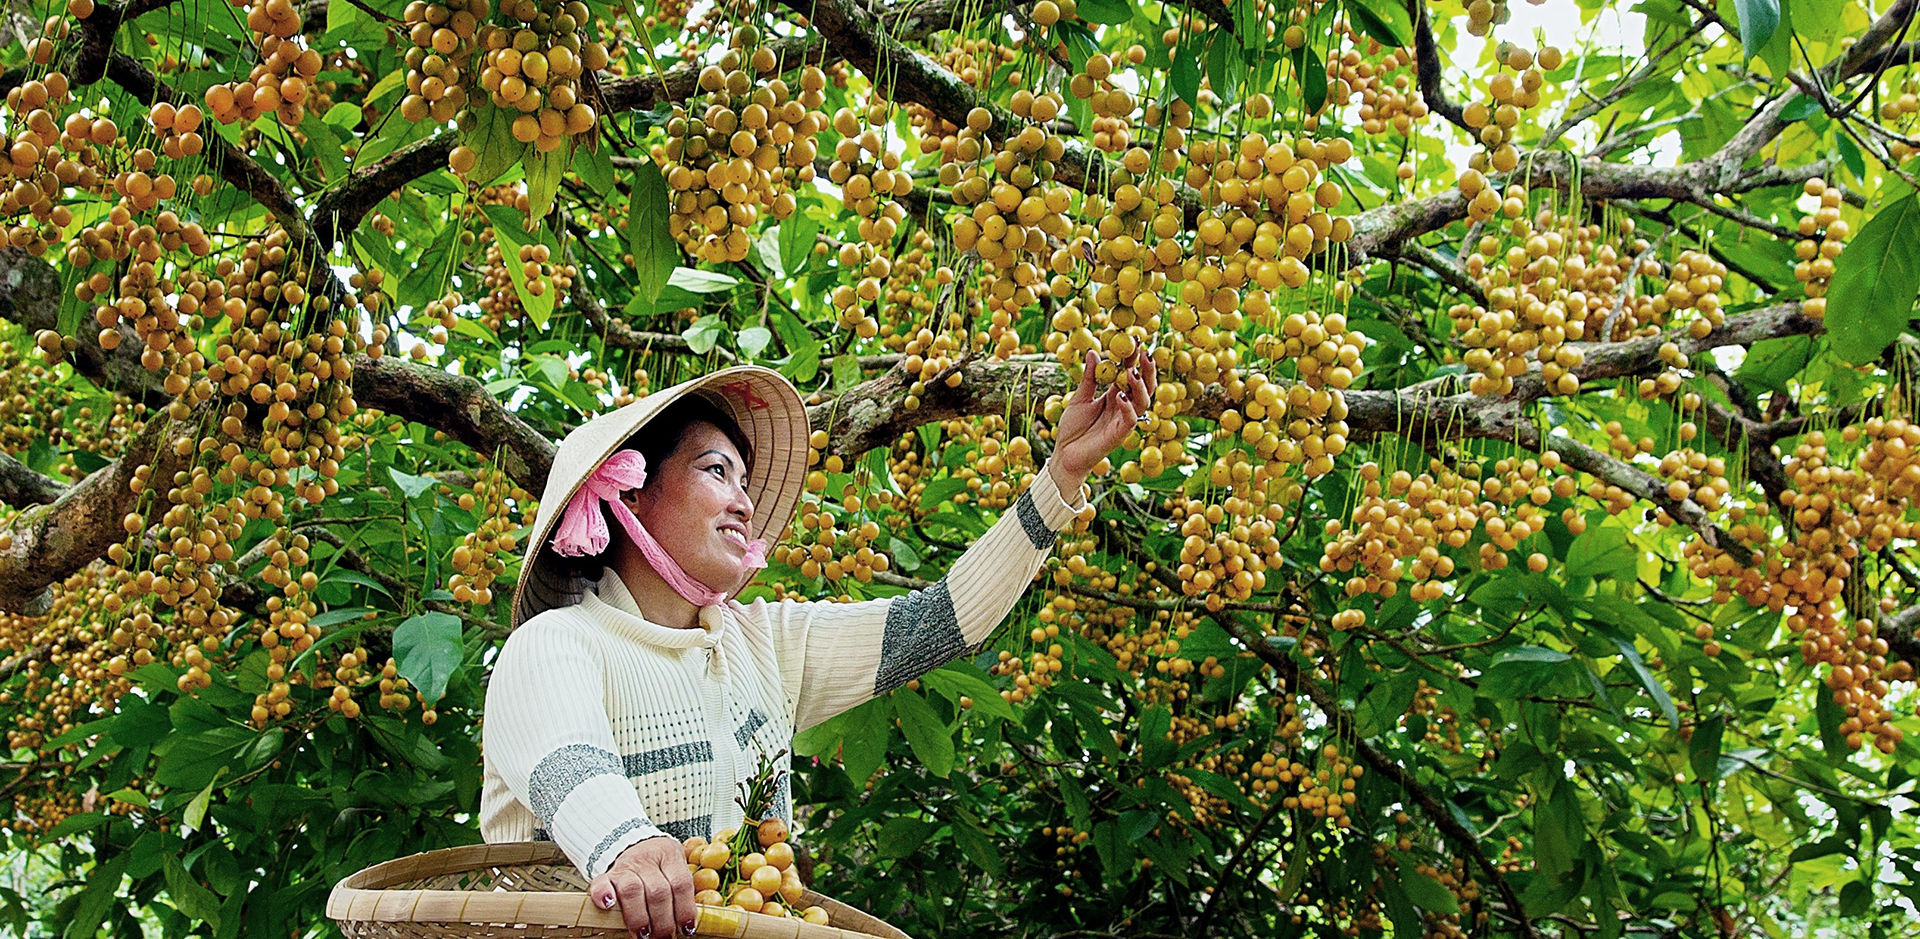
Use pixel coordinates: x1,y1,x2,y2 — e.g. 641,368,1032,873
326,841,908,939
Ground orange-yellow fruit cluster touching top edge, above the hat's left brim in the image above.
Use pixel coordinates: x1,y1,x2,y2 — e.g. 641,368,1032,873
472,0,607,151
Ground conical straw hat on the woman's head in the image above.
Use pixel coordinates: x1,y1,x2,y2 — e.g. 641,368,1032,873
513,365,808,626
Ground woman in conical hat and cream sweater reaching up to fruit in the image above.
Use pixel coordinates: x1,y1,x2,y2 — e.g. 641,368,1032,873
480,351,1156,935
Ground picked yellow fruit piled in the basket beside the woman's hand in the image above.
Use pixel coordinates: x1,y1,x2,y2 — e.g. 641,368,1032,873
682,818,828,926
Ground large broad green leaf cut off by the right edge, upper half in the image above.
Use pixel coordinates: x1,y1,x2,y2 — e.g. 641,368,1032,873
1826,192,1920,365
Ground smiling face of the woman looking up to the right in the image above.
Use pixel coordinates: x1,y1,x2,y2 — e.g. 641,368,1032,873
626,422,753,590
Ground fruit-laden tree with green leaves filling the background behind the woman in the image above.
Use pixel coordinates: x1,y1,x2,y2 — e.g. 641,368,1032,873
0,0,1920,939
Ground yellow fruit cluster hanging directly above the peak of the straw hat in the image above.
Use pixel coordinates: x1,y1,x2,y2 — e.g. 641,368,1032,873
653,42,826,263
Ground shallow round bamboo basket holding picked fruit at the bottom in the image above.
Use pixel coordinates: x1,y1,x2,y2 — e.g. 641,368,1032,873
326,841,910,939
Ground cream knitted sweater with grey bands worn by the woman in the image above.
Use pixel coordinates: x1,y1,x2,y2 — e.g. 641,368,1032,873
480,467,1085,878
